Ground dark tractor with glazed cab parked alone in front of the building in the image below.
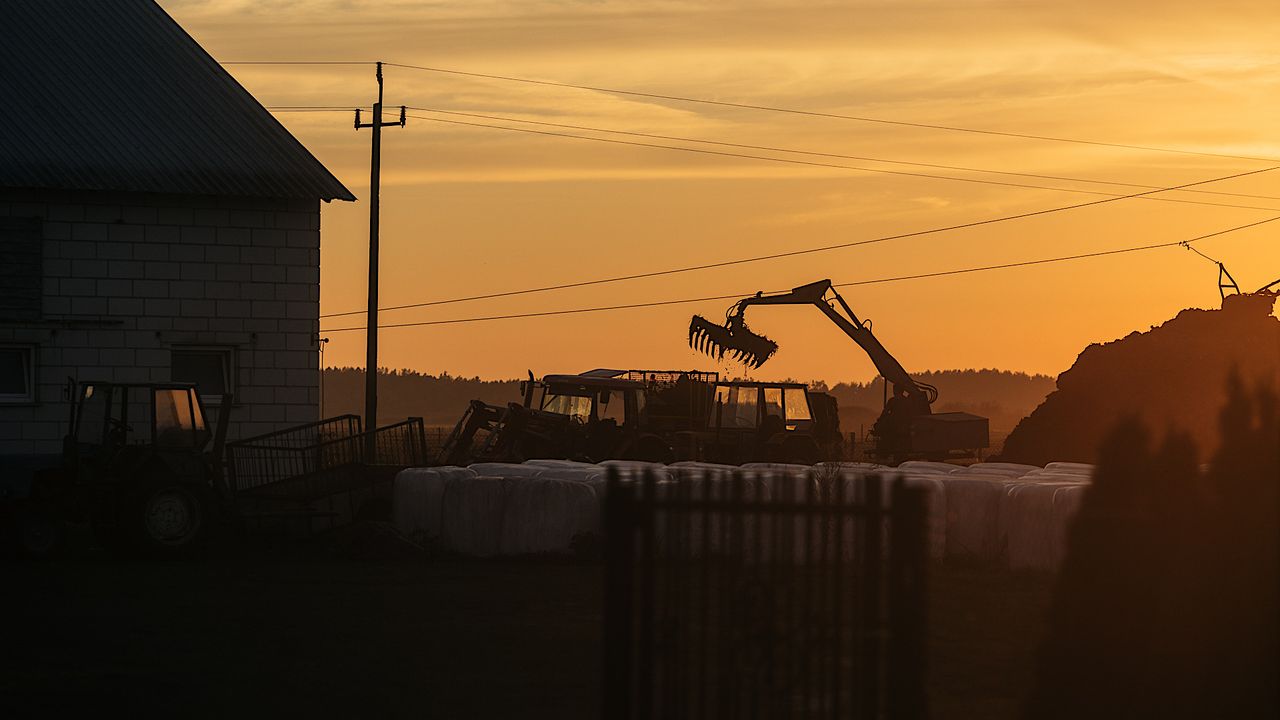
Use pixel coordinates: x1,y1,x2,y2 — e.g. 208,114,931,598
6,382,228,557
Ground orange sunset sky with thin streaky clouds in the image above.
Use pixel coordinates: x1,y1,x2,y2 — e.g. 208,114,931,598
161,0,1280,382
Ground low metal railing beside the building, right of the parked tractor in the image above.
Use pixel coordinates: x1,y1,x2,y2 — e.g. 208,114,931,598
225,415,428,496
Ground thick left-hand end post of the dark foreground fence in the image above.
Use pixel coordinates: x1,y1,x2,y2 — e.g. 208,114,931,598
600,468,636,720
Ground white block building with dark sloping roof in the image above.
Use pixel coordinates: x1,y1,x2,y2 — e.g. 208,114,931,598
0,0,355,455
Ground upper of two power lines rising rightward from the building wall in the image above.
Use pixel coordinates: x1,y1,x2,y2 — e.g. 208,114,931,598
320,163,1277,318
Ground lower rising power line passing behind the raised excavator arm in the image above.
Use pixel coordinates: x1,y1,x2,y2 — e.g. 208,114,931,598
321,215,1280,333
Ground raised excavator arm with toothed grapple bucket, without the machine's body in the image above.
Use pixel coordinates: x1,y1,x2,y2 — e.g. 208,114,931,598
689,281,937,414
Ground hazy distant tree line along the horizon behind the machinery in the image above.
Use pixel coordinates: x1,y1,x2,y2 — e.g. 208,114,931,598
321,368,1055,433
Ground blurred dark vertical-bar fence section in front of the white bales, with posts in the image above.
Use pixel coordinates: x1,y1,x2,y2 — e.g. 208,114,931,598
603,473,928,720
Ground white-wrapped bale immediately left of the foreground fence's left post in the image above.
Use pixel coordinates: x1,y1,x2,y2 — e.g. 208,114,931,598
498,477,600,555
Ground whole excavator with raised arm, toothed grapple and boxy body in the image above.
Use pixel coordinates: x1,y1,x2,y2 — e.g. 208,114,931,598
689,279,989,462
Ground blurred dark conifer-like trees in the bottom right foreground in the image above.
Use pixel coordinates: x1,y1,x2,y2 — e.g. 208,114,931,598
1027,375,1280,719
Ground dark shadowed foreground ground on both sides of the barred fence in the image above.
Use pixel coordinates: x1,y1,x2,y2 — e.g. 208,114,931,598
0,548,1050,720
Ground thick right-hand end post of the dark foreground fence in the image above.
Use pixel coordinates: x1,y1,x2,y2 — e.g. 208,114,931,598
888,478,929,720
